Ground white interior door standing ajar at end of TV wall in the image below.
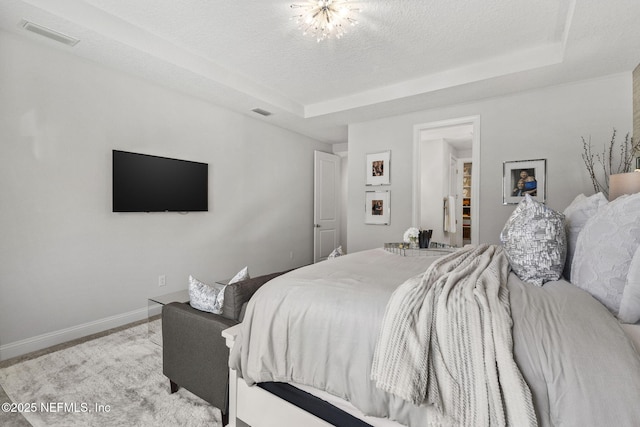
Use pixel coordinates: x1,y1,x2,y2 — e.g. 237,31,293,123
313,151,340,262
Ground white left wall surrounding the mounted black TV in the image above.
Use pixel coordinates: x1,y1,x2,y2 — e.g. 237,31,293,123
0,33,331,359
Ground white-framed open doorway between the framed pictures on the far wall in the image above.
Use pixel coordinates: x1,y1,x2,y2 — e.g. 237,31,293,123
413,116,480,246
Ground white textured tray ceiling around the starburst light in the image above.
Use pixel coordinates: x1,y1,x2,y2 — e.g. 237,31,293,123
0,0,640,143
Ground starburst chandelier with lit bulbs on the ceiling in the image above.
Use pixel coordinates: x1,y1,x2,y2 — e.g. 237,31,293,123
291,0,360,43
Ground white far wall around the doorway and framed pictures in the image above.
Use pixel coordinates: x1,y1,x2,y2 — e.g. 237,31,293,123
348,72,632,252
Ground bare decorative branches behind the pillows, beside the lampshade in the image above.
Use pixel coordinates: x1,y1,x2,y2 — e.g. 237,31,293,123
581,129,640,197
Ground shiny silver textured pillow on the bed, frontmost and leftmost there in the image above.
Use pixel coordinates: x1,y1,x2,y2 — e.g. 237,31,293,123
500,194,567,286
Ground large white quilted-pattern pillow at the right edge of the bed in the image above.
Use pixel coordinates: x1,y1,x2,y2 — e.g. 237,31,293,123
571,193,640,318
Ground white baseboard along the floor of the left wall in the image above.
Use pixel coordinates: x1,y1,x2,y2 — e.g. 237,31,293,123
0,307,148,361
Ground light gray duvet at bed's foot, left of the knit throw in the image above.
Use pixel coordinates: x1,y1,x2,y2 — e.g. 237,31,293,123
230,249,439,424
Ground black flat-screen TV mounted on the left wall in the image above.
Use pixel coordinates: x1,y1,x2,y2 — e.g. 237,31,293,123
113,150,209,212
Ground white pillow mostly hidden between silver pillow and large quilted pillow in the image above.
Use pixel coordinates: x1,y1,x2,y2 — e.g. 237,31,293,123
563,193,609,281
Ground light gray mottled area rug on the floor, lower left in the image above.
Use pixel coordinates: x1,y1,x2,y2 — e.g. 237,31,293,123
0,320,222,427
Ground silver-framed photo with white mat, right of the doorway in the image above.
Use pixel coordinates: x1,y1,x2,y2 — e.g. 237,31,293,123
502,159,547,205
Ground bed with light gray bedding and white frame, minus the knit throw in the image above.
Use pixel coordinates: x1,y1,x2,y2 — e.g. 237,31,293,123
225,198,640,427
